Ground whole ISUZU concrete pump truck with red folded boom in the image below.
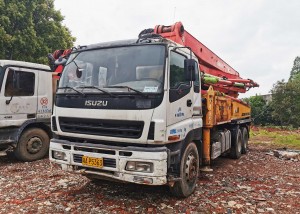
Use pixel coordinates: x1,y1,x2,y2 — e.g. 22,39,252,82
49,22,258,197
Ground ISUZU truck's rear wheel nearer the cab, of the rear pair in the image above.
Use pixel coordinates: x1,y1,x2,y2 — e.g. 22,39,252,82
230,126,242,159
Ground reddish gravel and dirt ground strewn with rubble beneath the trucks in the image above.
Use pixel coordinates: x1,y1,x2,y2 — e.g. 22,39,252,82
0,143,300,214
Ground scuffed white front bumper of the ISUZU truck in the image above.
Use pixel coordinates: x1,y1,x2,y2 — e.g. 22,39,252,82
49,139,168,185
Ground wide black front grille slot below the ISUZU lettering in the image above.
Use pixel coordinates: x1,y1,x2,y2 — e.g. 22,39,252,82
58,117,144,139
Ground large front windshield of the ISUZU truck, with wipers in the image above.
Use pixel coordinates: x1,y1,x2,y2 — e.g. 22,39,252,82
57,45,165,94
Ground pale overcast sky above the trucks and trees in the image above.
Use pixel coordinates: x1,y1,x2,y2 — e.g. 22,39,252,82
55,0,300,97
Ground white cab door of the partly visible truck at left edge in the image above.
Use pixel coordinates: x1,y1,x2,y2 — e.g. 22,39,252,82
0,67,38,127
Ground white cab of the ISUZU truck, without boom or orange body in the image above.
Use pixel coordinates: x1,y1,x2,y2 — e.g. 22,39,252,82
49,40,202,195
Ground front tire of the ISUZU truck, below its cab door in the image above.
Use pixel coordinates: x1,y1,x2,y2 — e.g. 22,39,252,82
170,142,199,198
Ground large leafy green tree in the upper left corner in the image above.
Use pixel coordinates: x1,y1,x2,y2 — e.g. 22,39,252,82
0,0,75,63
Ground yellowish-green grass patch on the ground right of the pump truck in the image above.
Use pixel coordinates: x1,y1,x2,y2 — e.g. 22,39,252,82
250,128,300,149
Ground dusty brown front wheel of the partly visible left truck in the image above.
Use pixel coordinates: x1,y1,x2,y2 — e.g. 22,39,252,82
14,128,50,161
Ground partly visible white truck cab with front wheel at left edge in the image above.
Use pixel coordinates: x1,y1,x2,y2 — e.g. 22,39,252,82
0,60,53,161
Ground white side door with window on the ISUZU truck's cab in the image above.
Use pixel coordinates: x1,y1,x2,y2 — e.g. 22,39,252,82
166,49,202,140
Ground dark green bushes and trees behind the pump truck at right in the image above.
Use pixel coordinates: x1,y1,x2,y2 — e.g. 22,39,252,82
245,57,300,128
